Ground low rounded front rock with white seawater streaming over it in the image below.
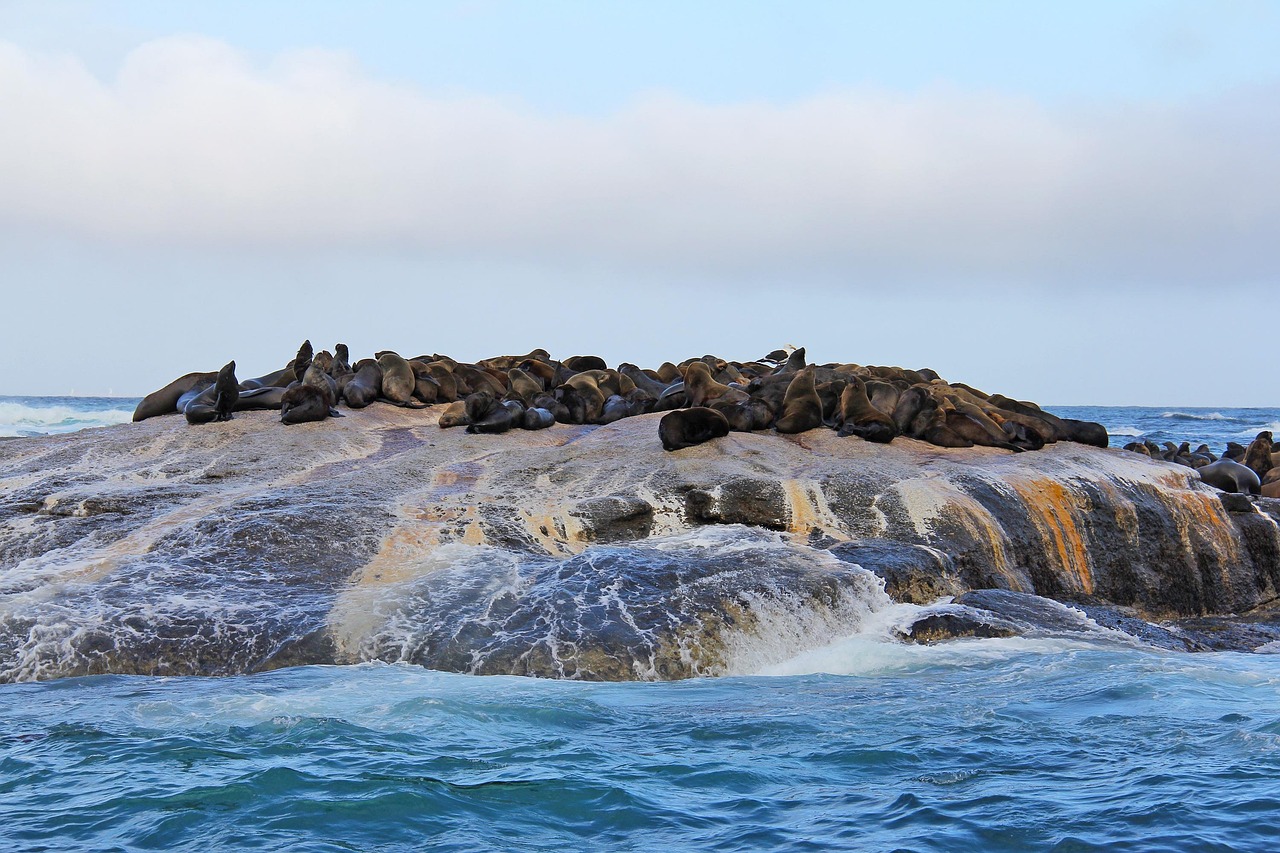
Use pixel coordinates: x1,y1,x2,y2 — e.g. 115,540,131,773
330,525,892,680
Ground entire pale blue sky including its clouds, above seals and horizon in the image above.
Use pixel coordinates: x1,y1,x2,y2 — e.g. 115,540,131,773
0,0,1280,406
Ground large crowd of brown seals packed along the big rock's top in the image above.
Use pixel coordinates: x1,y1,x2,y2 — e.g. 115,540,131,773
133,341,1107,451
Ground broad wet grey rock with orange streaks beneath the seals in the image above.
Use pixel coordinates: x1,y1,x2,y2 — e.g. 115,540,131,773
0,405,1280,680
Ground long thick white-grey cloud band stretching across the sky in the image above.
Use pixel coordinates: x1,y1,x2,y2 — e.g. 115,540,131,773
0,37,1280,286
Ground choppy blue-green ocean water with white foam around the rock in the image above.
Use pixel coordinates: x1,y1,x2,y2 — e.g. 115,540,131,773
0,397,1280,852
